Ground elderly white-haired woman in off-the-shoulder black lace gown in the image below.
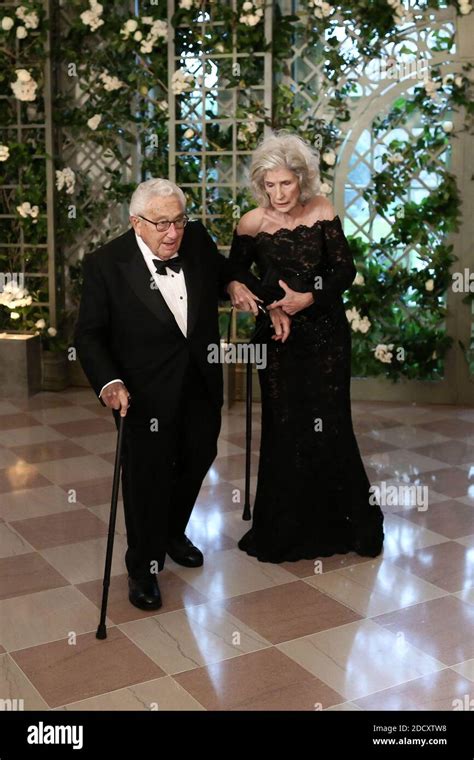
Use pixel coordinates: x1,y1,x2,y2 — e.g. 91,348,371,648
230,133,384,562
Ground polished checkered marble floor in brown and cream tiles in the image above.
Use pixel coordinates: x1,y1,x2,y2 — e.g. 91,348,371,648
0,388,474,710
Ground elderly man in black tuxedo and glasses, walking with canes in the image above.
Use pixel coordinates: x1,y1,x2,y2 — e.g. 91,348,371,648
75,179,289,610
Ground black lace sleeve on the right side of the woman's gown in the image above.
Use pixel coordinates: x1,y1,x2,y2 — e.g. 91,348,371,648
312,216,357,310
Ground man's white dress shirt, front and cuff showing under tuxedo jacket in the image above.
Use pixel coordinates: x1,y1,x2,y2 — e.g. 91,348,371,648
99,233,188,398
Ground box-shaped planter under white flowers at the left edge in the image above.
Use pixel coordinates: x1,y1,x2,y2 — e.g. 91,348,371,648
0,331,41,398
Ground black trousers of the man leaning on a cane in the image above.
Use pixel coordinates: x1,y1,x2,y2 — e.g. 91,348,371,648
113,362,221,578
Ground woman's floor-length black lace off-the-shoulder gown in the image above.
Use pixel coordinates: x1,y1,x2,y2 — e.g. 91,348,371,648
230,216,384,562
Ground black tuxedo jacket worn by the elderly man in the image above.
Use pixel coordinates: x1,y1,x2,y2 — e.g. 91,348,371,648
74,221,232,422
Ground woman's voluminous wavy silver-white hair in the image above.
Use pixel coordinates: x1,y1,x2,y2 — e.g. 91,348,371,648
250,129,321,206
